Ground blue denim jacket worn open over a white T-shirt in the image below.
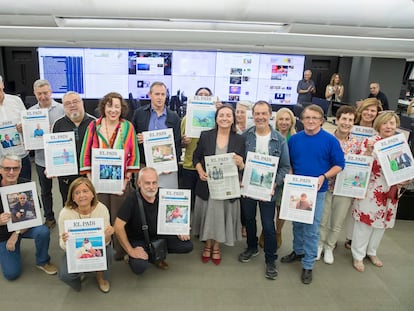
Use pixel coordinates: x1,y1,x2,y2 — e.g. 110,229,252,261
242,126,290,201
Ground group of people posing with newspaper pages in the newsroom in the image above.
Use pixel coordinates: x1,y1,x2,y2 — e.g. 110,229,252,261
0,71,410,293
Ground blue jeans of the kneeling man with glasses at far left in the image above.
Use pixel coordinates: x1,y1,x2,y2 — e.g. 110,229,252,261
0,225,50,280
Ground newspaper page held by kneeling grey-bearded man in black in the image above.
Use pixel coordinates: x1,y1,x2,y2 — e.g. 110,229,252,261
157,188,191,235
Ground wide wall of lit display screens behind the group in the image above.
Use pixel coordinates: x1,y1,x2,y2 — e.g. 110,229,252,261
38,48,305,105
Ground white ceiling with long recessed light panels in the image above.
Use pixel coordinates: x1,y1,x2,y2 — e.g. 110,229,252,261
0,0,414,60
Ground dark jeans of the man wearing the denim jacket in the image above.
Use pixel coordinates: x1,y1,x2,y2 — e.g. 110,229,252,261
242,198,277,263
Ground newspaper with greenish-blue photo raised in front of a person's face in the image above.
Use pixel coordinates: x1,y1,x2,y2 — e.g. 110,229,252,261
185,96,218,138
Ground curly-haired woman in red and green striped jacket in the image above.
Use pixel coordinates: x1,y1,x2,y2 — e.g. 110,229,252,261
80,92,139,260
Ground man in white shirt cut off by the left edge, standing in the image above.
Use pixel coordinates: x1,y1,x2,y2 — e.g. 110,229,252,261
0,76,32,180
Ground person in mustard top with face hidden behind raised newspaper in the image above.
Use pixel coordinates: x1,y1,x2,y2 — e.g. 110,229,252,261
180,87,221,210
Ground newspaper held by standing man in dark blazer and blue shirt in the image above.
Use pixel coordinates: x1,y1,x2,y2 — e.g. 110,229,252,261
142,128,178,174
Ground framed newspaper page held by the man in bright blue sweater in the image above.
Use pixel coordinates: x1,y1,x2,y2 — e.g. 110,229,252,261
279,174,318,224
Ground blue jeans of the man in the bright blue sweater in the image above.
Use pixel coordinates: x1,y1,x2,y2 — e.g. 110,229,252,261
292,192,326,270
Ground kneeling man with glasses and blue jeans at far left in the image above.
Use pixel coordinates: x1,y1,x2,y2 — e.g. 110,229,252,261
0,155,57,280
